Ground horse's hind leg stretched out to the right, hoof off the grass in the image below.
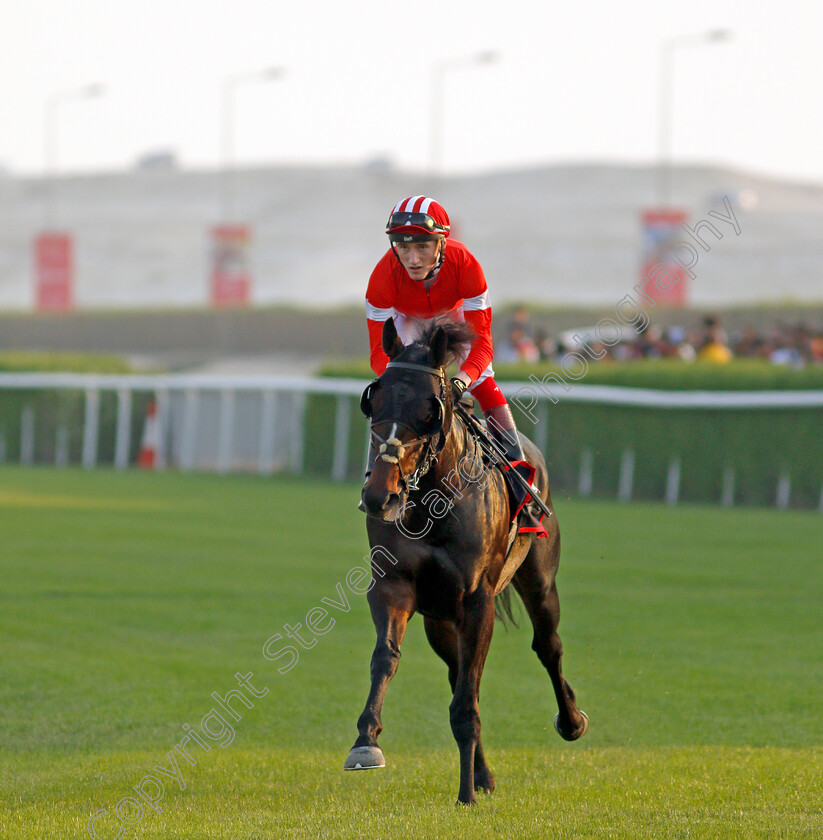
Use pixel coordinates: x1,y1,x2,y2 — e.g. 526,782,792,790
512,540,589,741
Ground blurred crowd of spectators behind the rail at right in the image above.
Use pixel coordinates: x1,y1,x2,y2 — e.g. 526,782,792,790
495,307,823,367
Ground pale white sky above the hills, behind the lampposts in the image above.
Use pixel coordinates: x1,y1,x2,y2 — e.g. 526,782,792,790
0,0,823,182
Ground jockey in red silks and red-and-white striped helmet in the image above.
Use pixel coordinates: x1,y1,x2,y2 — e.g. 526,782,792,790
366,195,546,536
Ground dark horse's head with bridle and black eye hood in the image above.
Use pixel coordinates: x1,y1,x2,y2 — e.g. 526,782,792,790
360,318,472,521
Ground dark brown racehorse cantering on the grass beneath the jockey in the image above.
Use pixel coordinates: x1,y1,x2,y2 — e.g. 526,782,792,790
344,319,588,805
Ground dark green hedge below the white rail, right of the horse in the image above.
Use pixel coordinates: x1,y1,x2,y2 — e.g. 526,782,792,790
515,403,823,508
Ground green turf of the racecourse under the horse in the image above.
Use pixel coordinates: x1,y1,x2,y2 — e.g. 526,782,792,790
0,468,823,840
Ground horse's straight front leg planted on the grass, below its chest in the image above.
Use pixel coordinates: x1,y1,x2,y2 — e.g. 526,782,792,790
449,587,494,805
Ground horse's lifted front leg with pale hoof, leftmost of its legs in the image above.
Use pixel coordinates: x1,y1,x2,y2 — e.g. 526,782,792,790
343,578,415,770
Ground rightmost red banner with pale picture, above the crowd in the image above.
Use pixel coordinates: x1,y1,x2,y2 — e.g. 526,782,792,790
642,208,689,306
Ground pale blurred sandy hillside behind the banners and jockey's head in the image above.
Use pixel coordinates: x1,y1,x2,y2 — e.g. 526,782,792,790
0,164,823,311
